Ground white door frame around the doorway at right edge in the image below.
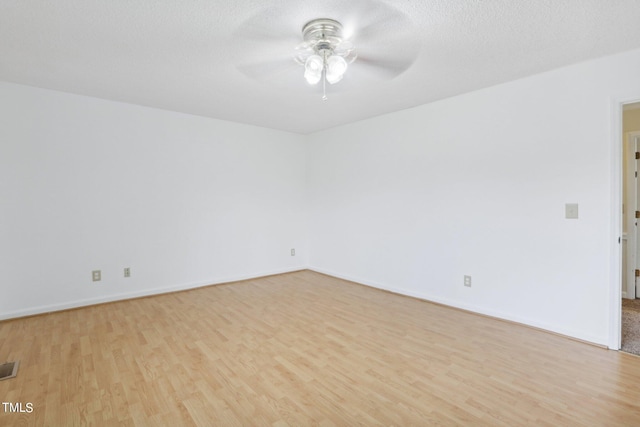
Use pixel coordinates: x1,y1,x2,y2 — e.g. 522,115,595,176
607,97,640,350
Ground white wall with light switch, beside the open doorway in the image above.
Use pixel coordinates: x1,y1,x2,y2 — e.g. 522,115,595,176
308,51,640,345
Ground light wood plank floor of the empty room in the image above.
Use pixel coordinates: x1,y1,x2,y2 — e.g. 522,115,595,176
0,271,640,427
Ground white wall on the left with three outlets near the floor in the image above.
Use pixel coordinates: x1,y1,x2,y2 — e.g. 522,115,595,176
0,83,307,318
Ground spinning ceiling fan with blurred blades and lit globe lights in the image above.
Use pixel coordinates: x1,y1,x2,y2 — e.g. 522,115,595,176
233,0,418,100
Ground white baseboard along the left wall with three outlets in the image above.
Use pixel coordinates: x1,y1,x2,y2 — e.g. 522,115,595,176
0,266,307,320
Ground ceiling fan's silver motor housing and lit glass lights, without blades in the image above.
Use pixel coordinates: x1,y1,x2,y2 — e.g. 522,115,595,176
295,18,357,100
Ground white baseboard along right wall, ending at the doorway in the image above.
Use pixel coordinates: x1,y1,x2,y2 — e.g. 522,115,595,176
308,267,607,347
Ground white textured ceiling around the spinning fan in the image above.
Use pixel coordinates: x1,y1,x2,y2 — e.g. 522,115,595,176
0,0,640,133
